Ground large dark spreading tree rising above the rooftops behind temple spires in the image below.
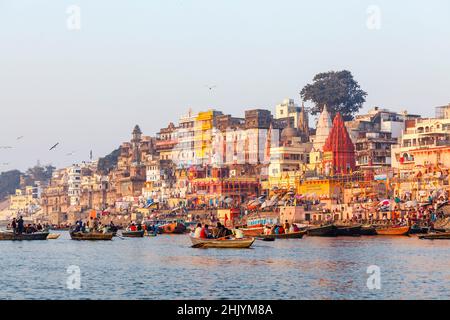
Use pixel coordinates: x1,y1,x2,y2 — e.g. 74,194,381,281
300,70,367,120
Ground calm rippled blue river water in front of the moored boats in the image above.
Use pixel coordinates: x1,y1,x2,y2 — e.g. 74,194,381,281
0,232,450,299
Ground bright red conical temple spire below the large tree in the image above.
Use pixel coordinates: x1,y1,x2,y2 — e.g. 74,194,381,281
323,113,356,174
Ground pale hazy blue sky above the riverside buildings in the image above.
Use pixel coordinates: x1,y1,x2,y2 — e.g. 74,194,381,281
0,0,450,171
